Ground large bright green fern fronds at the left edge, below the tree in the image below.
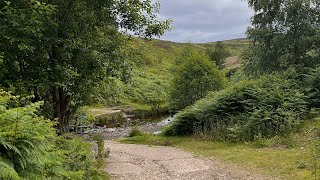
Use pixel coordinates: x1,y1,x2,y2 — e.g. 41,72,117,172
0,91,55,179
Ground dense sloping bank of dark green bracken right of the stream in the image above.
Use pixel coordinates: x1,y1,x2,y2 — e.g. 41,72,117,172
164,70,308,141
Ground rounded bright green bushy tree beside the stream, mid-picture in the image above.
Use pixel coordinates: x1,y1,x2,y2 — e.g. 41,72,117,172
170,48,226,110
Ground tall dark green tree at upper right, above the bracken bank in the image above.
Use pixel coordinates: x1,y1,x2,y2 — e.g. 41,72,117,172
245,0,320,72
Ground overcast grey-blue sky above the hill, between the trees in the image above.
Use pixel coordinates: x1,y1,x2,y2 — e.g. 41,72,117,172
159,0,253,42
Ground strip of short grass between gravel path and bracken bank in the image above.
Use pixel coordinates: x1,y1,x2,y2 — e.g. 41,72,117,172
119,120,320,179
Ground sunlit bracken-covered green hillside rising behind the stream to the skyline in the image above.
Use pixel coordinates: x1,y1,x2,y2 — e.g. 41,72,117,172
89,38,250,119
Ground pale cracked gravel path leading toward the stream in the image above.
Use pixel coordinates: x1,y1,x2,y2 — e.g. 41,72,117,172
105,141,271,180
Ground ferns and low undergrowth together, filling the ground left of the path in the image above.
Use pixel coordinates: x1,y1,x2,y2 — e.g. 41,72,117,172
0,91,105,179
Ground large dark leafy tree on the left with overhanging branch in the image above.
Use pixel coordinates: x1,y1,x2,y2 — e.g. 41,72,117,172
0,0,170,132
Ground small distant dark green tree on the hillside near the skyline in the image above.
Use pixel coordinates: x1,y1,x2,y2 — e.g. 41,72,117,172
208,41,230,69
